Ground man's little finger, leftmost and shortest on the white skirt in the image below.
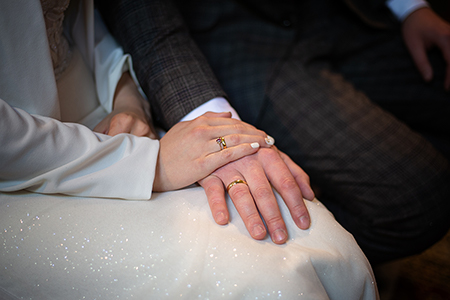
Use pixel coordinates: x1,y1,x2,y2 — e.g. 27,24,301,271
198,175,230,225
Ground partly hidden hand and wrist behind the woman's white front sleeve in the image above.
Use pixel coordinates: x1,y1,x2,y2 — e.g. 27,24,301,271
94,72,157,139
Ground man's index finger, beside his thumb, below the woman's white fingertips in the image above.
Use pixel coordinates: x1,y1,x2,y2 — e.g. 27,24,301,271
262,149,311,229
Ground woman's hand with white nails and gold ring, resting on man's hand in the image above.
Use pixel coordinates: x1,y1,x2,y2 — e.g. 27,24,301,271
153,112,274,192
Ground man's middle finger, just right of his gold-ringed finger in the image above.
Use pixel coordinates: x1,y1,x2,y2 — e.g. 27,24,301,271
243,159,288,244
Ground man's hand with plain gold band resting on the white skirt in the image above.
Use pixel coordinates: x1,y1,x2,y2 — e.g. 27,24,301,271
199,147,314,244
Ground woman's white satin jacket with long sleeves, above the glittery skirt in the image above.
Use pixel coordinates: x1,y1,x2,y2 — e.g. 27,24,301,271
0,0,159,199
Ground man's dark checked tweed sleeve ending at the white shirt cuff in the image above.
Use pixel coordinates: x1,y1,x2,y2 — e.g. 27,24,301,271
96,0,225,129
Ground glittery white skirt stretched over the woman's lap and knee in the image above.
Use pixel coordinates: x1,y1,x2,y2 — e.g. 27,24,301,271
0,188,377,299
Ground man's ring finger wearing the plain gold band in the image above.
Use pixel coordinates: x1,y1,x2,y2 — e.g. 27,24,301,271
218,172,267,240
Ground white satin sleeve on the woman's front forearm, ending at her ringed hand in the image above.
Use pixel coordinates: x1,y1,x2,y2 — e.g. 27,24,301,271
0,99,159,199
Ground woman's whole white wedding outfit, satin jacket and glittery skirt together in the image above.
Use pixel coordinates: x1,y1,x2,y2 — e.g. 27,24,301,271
0,0,378,300
